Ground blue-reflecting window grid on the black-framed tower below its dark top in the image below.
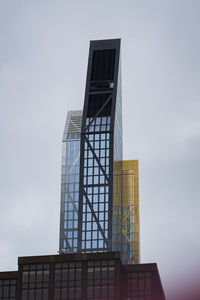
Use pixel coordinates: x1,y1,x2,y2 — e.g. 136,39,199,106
82,116,110,252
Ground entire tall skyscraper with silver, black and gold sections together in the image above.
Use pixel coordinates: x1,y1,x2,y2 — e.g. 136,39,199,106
59,39,139,263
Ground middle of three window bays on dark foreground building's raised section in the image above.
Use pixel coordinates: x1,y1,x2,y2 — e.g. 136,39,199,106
54,262,82,300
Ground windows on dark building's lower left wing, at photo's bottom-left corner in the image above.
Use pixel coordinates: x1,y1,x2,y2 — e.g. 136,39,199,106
0,279,16,300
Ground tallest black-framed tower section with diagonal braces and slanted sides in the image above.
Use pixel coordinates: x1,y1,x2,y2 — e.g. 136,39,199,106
78,39,122,252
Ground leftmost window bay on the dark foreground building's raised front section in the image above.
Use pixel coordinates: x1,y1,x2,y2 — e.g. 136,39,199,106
21,264,49,300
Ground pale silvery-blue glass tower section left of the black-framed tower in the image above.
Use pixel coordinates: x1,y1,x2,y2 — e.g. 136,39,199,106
59,111,82,253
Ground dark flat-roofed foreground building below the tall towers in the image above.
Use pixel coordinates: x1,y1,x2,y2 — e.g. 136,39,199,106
0,252,165,300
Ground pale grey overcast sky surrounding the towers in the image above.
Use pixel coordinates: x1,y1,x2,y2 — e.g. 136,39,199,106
0,0,200,296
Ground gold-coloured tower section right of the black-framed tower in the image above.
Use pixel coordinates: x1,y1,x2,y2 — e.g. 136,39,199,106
113,160,140,264
